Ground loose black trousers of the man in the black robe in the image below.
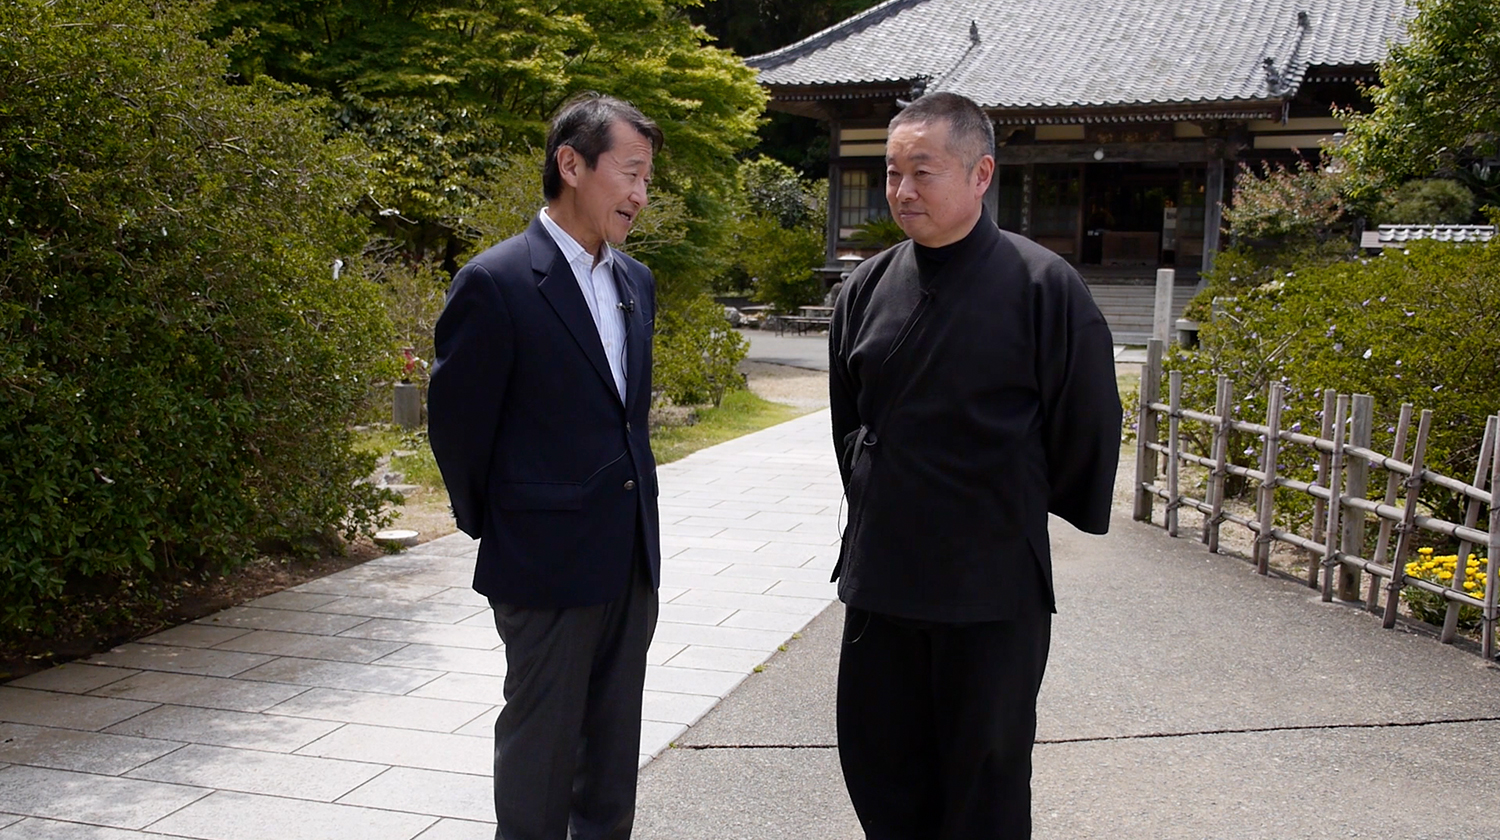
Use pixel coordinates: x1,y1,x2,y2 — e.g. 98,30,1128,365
837,608,1052,840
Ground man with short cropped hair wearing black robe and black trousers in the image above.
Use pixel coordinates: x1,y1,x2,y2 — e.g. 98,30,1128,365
830,93,1121,840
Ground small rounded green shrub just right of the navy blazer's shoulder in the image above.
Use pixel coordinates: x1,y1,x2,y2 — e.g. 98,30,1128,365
653,297,747,405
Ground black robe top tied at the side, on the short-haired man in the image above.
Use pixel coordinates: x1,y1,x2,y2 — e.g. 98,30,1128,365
830,213,1121,623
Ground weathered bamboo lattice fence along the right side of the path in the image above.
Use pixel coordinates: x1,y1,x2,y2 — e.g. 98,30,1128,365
1134,341,1500,659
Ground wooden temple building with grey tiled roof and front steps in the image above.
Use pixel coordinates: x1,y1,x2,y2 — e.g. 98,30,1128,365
747,0,1415,307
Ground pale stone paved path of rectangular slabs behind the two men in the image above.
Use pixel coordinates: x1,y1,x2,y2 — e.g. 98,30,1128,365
0,413,840,840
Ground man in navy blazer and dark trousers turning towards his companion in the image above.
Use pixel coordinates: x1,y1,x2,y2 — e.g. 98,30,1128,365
428,95,662,840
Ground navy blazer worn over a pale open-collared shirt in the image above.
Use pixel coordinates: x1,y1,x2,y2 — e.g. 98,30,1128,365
428,219,662,608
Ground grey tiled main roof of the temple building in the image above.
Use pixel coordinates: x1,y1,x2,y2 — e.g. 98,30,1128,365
747,0,1413,108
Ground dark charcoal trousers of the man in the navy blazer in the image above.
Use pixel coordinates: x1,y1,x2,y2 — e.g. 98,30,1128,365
491,552,657,840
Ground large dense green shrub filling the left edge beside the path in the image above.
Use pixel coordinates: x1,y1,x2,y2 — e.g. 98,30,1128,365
0,0,392,635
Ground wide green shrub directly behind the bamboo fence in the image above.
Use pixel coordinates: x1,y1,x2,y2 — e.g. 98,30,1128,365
1169,242,1500,521
